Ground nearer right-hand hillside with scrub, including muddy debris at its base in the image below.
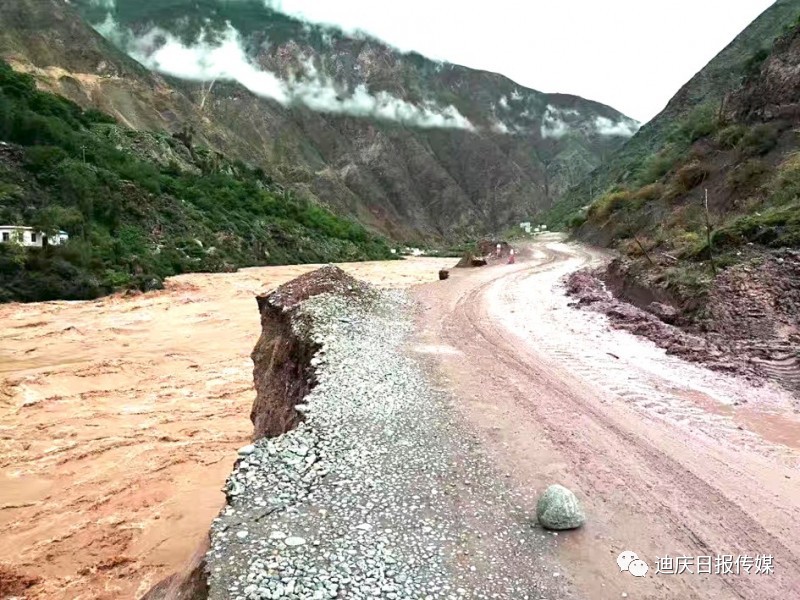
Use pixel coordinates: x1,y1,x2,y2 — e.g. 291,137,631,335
560,22,800,398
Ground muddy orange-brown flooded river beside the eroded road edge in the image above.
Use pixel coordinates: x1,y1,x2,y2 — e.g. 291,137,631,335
0,258,444,600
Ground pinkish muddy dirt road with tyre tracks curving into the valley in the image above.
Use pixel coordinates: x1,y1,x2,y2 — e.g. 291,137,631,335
414,238,800,600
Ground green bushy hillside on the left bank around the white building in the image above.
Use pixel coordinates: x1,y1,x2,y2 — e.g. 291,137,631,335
0,62,391,301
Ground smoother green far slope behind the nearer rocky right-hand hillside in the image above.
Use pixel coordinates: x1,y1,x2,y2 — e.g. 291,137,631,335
548,0,800,226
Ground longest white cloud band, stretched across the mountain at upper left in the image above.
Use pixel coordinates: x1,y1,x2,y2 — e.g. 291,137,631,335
104,17,474,130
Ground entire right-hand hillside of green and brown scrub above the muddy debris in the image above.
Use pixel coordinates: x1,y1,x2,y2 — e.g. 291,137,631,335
550,0,800,319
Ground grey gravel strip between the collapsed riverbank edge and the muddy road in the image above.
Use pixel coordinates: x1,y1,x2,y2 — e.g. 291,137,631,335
208,292,573,600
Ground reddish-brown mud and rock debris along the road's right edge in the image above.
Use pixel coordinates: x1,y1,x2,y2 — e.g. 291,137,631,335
567,250,800,393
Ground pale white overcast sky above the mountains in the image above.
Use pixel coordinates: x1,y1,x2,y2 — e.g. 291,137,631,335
265,0,773,122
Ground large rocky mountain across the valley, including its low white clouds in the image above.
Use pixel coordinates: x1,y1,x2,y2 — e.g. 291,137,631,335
0,0,638,240
